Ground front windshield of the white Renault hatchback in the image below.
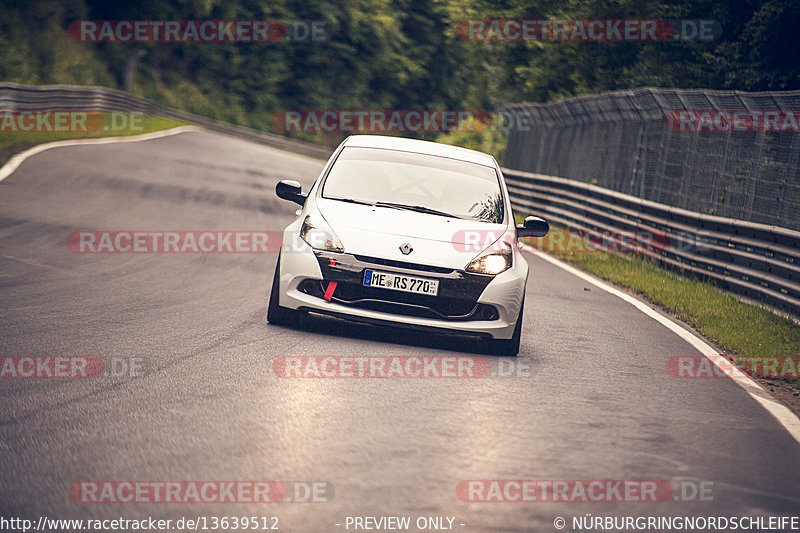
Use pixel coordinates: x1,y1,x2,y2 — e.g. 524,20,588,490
322,146,504,223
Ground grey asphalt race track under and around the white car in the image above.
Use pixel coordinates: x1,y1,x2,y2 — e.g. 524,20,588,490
0,132,800,532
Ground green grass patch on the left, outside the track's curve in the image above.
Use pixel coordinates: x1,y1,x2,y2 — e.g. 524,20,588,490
0,112,188,166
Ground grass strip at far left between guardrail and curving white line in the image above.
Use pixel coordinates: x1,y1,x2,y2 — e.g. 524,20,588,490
0,113,187,165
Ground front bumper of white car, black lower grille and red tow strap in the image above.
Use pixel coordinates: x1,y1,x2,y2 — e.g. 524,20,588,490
280,236,528,339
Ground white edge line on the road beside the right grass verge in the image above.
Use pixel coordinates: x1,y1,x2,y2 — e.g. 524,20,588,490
523,245,800,443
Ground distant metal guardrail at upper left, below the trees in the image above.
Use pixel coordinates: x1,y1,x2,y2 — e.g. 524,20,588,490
0,82,333,159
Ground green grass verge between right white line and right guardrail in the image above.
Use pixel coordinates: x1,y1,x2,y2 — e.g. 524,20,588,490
521,217,800,387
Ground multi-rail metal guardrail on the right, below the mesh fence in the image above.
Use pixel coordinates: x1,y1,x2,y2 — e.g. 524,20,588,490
503,168,800,316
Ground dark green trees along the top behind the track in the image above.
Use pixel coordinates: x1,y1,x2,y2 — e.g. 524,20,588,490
0,0,800,151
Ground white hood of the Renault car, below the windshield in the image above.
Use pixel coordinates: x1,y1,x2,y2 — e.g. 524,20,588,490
316,198,507,268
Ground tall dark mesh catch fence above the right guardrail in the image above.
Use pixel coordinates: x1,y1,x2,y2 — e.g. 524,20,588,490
503,88,800,230
